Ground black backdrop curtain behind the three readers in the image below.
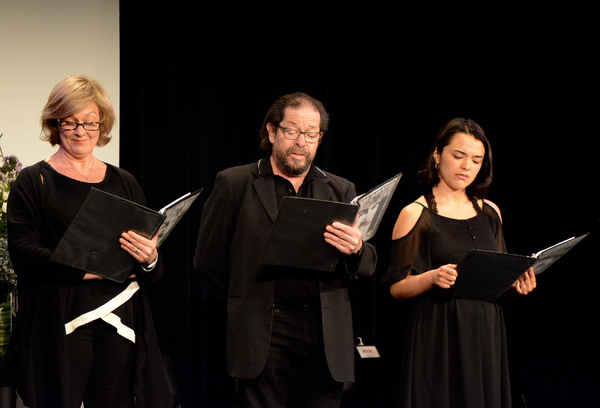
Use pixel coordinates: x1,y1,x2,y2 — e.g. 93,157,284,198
120,2,600,408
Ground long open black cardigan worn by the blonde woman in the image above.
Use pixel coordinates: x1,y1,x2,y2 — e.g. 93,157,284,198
1,161,172,408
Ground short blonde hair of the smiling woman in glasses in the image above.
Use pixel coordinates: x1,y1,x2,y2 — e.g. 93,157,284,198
40,75,115,147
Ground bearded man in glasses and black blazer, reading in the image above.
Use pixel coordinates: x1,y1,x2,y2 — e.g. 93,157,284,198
194,93,377,408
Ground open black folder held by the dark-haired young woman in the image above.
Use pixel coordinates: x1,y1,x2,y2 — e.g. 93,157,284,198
433,232,589,302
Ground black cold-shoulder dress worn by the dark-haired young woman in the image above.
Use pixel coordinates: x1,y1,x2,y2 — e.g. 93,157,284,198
383,199,511,408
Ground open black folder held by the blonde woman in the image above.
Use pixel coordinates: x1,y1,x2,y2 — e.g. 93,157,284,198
50,187,200,282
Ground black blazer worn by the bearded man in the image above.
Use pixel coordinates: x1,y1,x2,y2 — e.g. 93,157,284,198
194,159,377,382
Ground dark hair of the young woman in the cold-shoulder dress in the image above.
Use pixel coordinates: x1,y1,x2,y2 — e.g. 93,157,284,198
419,118,492,198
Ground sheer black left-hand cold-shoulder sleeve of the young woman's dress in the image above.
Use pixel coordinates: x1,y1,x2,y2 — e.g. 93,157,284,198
381,210,432,285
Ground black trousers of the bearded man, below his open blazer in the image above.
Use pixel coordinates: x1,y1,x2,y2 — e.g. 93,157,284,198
234,305,344,408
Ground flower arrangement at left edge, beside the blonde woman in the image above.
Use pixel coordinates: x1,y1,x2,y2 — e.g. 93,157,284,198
0,134,23,290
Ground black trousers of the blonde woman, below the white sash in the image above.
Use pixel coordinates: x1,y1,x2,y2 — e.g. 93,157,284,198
67,319,135,408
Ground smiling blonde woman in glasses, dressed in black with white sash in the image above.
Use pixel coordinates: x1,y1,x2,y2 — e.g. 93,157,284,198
3,76,172,408
